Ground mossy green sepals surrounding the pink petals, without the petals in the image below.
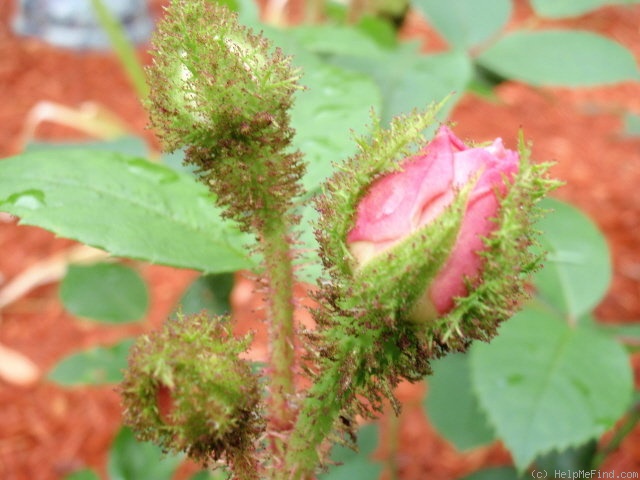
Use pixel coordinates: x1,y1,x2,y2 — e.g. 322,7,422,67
316,105,558,344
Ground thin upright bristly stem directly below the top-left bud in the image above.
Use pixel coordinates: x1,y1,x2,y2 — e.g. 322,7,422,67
262,218,295,468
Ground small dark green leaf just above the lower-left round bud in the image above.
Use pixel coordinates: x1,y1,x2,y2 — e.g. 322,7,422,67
178,273,234,315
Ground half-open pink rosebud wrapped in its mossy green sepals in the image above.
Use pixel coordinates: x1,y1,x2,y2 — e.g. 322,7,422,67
317,106,559,352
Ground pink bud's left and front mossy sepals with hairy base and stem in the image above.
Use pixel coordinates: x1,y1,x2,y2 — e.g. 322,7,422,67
288,102,464,478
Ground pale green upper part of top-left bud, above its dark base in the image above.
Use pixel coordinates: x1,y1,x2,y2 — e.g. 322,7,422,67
147,0,299,154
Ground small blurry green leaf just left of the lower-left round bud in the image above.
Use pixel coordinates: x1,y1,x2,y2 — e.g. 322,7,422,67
47,338,133,386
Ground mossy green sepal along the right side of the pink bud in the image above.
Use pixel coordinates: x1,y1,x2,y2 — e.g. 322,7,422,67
427,134,561,350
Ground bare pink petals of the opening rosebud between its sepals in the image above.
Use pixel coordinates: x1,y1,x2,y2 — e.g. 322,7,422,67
347,126,519,319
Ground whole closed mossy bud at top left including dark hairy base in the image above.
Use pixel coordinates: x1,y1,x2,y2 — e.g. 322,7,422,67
147,0,304,231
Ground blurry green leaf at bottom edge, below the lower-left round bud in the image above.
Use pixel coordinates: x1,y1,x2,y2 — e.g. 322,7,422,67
107,427,182,480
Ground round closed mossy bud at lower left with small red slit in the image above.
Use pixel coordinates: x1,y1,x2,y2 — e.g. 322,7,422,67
121,314,262,468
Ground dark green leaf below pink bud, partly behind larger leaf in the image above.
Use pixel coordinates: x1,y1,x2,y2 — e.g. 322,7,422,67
424,353,495,450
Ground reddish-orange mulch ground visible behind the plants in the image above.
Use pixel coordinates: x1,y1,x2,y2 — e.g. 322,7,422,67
0,0,640,480
